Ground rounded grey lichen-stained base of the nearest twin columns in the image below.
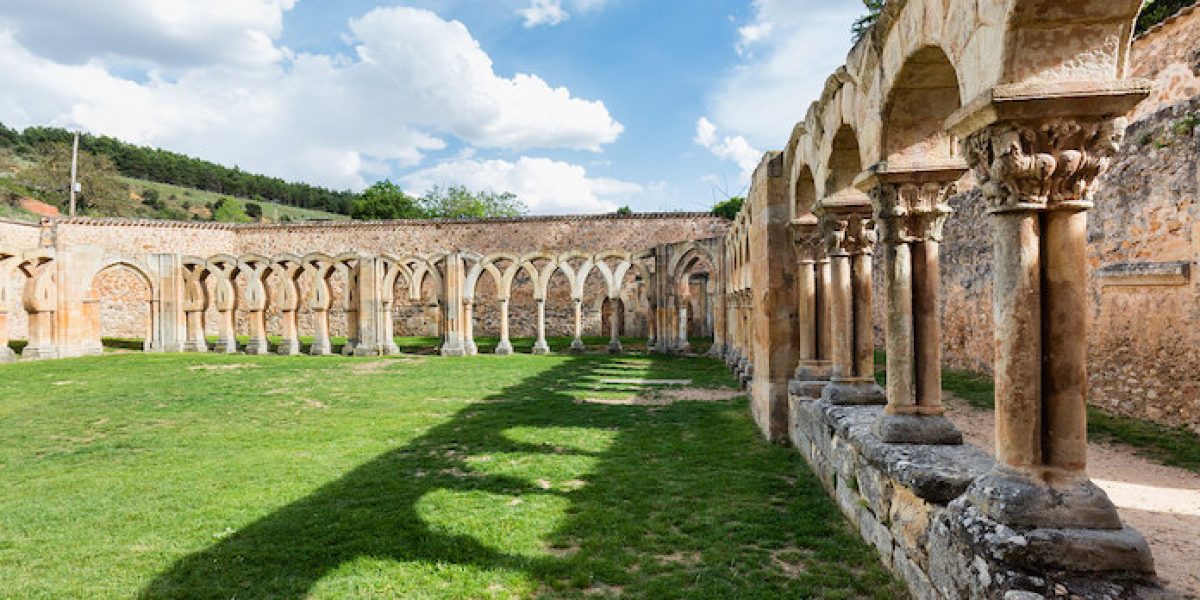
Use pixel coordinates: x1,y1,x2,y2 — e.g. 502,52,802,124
964,467,1123,530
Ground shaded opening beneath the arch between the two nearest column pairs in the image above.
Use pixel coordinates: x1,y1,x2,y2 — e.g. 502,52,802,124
883,46,962,170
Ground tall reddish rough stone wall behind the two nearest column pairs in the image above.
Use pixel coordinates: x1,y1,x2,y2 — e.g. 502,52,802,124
942,97,1200,431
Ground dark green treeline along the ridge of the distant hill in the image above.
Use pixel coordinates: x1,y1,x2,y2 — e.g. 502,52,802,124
0,124,356,215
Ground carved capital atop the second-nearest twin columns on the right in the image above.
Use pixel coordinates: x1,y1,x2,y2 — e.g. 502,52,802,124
871,181,958,244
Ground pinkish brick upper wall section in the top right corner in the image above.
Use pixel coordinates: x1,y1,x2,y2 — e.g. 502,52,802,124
1129,5,1200,119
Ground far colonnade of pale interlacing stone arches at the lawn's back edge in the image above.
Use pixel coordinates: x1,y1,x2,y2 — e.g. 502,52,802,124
0,240,724,361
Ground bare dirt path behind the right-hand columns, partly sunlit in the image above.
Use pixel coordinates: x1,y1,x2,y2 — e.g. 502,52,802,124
947,396,1200,598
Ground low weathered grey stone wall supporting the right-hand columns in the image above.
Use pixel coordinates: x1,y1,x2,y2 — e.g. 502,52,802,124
788,395,1152,600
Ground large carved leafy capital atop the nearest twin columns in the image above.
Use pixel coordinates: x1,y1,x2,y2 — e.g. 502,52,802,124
964,116,1127,211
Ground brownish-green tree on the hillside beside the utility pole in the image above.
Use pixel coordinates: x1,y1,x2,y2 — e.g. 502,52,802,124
16,144,126,216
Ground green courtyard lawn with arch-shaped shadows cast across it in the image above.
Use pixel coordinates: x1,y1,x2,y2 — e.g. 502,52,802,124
0,345,905,599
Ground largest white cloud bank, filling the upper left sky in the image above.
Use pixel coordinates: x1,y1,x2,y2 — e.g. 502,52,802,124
0,0,623,187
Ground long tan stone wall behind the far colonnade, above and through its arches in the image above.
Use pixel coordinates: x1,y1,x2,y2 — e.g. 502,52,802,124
7,212,727,340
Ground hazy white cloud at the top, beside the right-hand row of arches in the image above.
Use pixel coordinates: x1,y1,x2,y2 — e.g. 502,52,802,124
708,0,863,149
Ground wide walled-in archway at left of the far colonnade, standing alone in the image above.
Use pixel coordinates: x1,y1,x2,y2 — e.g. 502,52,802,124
84,263,154,354
